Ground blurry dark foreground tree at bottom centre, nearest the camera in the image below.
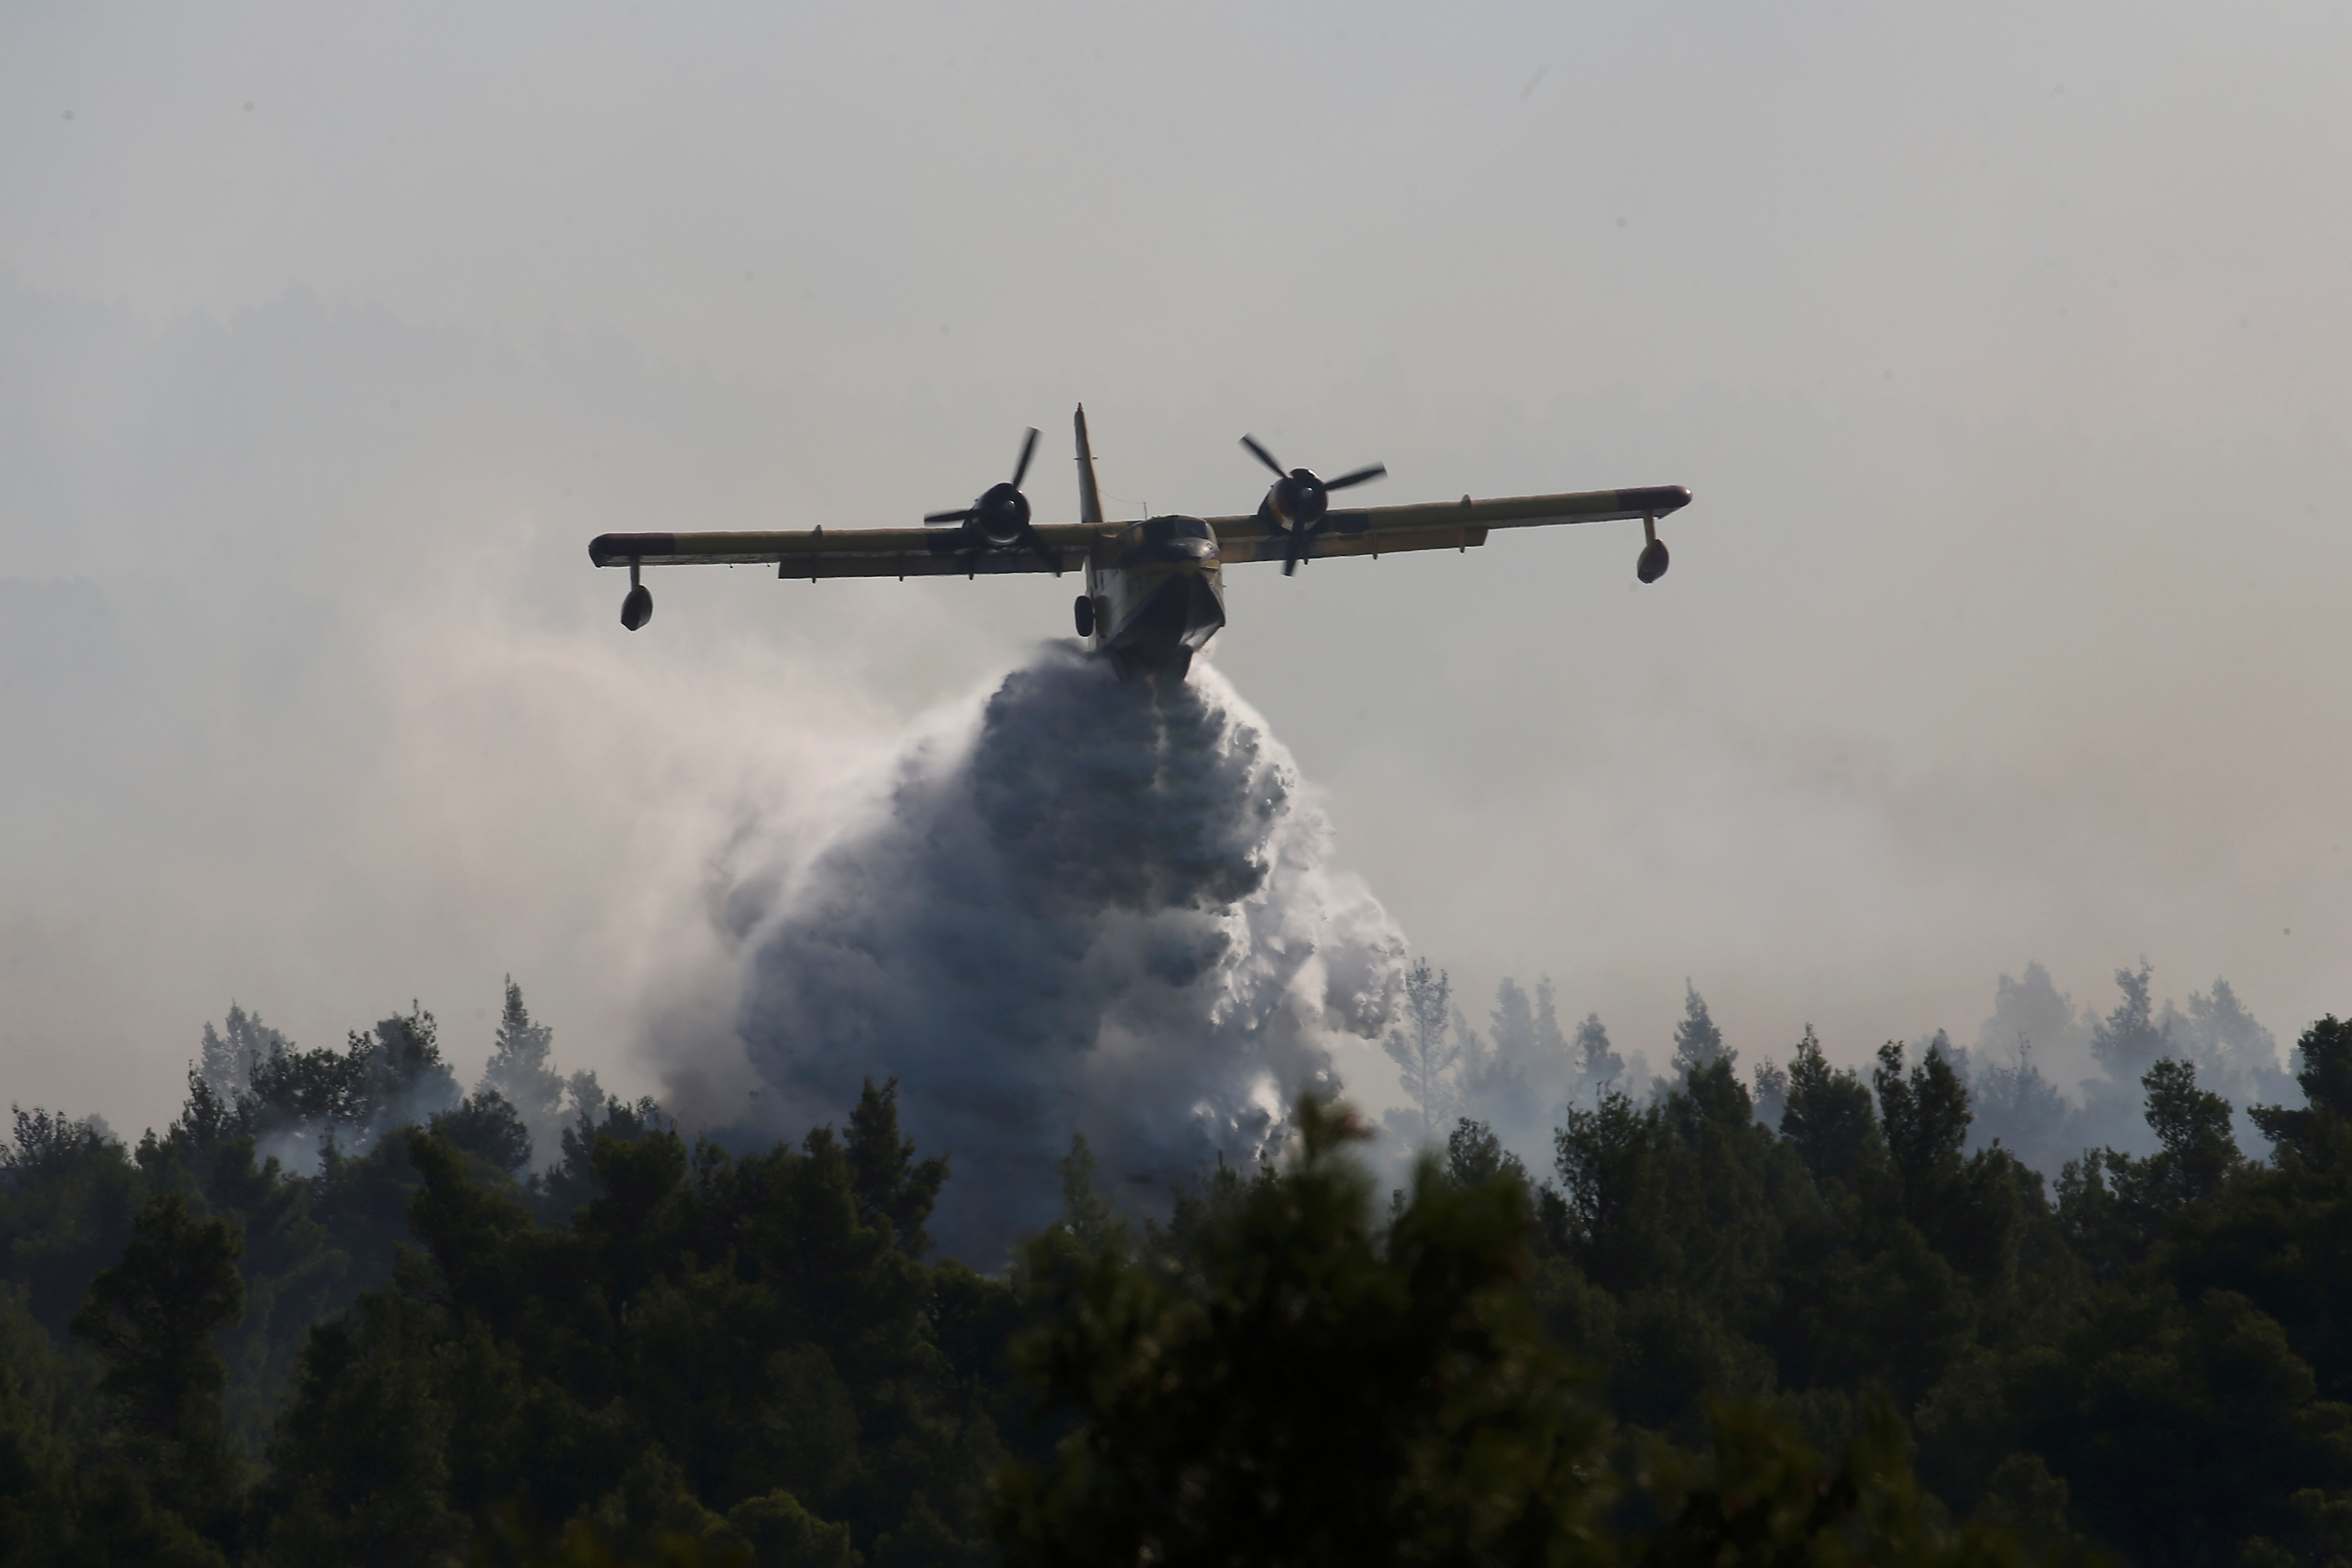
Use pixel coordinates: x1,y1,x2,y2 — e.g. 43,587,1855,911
997,1100,1602,1565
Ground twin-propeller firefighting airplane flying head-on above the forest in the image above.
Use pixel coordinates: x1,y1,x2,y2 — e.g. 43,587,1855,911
588,404,1691,679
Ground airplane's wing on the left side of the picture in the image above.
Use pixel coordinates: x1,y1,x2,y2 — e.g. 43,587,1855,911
588,522,1103,581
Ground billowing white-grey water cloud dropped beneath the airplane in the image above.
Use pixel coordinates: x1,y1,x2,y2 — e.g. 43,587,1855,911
729,644,1404,1263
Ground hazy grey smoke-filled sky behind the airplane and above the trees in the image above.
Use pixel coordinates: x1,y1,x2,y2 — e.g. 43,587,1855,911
0,0,2352,1129
